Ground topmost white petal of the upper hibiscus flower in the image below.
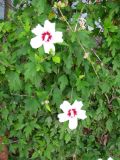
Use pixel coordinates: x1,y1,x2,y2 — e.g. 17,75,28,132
44,20,55,33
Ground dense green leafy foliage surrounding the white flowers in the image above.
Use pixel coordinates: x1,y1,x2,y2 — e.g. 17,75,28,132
0,0,120,160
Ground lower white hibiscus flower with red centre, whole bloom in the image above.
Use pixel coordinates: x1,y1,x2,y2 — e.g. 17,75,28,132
58,100,87,130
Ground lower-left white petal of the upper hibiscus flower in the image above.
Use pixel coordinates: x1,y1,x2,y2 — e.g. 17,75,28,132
30,36,43,48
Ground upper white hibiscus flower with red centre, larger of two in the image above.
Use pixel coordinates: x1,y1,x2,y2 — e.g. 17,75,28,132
30,20,63,53
